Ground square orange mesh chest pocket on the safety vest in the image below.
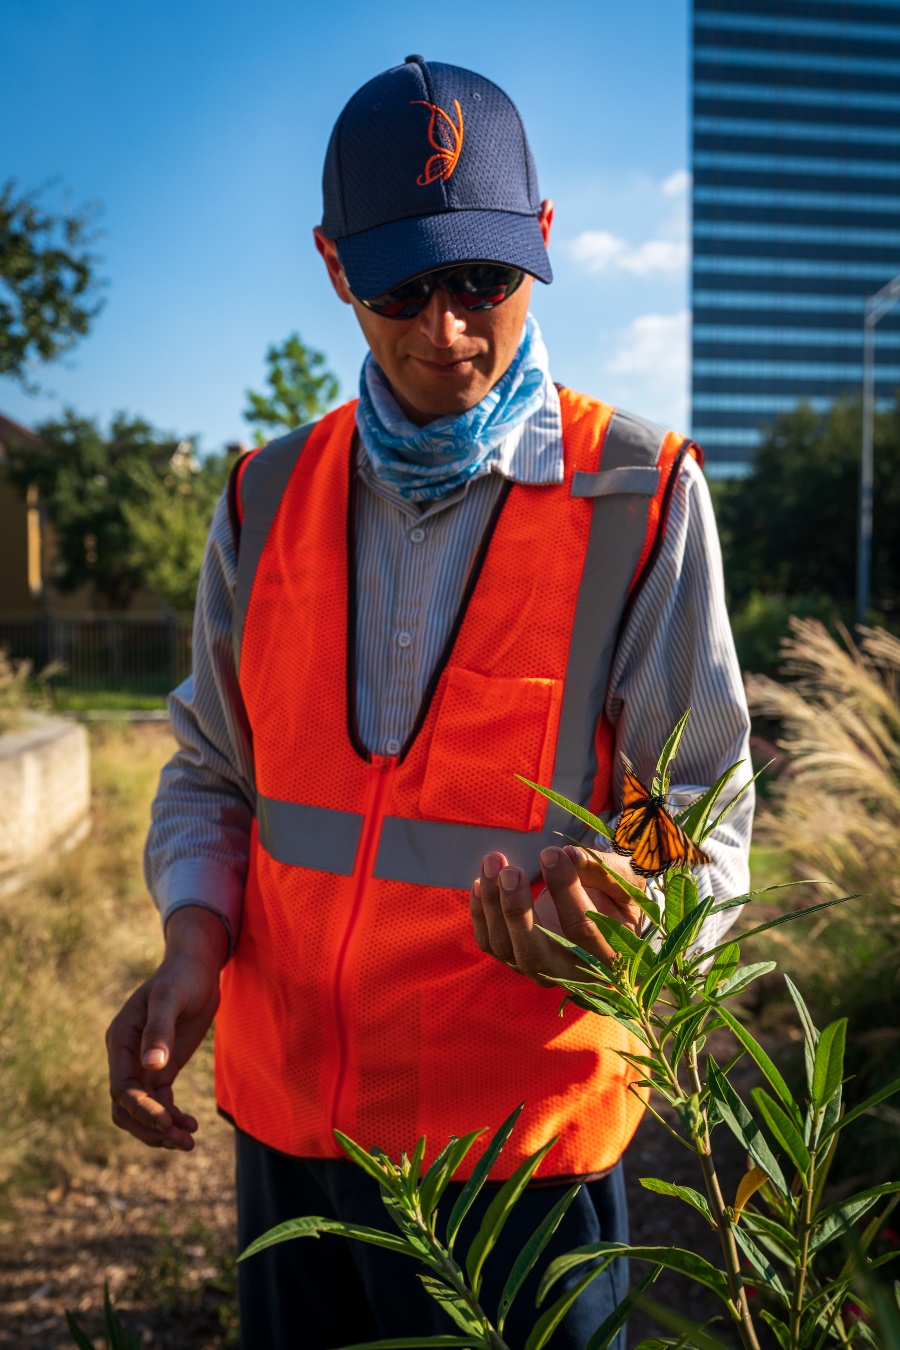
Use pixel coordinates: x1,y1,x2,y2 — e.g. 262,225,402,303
420,666,563,830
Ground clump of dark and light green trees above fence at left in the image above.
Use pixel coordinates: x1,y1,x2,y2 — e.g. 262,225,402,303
5,409,215,610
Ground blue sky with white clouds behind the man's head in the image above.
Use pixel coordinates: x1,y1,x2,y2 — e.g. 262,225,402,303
0,0,688,450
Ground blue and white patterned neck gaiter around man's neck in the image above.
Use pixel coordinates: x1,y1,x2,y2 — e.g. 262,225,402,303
356,313,549,502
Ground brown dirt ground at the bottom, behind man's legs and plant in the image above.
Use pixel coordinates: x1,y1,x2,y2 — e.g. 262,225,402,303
0,1020,761,1350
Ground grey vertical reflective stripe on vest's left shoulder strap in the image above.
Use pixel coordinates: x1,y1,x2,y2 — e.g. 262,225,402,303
232,423,316,671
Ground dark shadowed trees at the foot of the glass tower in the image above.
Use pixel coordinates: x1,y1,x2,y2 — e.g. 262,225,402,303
716,396,900,610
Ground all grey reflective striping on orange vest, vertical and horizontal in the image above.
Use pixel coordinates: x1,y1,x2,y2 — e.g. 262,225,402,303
235,399,667,890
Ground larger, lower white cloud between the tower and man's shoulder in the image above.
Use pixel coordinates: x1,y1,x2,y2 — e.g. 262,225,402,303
606,309,691,429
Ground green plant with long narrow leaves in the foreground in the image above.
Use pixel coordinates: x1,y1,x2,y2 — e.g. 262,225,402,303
240,713,900,1350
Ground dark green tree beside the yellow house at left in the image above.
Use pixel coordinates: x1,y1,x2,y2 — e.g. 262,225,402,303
5,409,182,609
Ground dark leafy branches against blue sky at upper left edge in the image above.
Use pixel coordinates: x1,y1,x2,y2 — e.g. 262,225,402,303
0,180,103,393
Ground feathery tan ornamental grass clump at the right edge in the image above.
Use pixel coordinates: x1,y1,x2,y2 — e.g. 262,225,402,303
748,618,900,1175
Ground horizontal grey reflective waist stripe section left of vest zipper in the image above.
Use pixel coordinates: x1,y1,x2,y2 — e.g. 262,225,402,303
256,797,361,882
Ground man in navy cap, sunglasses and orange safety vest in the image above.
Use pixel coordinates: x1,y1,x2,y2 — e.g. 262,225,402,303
109,57,750,1350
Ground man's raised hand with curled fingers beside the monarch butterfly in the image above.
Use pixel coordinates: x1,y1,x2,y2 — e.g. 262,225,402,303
470,844,645,984
